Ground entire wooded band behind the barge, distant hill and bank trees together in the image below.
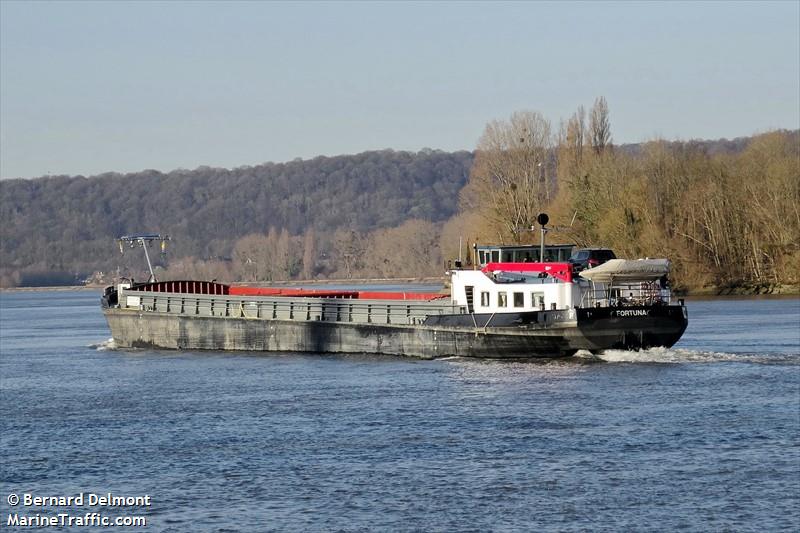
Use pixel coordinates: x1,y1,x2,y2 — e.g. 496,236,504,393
0,97,800,295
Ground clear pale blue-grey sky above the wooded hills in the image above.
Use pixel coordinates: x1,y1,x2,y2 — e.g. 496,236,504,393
0,0,800,178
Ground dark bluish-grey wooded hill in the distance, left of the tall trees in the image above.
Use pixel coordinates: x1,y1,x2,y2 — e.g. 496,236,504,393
0,150,472,286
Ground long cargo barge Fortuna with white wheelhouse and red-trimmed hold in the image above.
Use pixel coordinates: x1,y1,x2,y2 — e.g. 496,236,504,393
102,236,688,359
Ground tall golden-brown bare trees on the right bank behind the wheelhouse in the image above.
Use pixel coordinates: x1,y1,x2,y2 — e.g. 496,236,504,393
461,97,800,289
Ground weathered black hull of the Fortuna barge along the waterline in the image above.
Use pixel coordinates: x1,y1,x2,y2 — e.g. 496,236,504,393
104,306,687,358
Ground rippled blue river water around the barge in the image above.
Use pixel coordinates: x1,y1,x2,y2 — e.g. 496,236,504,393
0,291,800,532
